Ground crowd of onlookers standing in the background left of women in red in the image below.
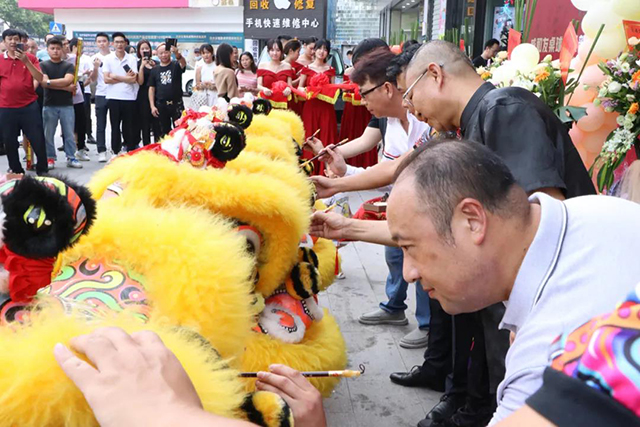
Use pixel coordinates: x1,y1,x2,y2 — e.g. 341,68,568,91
0,29,258,174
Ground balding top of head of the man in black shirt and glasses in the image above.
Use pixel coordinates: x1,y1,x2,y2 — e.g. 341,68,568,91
407,40,476,75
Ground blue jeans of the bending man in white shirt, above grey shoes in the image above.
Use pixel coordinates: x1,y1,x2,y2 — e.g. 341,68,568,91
380,246,431,329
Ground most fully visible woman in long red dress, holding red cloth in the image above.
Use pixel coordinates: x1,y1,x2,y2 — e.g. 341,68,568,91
299,40,340,174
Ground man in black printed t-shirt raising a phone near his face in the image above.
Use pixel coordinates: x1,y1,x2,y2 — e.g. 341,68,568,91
149,39,187,138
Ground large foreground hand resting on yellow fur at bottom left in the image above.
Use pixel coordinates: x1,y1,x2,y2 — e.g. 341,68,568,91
54,328,202,427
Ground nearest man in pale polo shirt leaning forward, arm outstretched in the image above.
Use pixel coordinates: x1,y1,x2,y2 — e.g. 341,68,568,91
311,141,640,423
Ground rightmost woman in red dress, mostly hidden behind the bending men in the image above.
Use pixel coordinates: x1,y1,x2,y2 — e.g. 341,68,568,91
339,67,378,168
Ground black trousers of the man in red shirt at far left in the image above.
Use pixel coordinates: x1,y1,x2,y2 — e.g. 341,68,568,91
0,101,48,173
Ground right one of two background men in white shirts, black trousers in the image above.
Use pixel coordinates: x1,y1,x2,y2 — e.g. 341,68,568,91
103,32,139,154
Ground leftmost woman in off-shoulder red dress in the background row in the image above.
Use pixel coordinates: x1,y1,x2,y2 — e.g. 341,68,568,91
258,39,294,109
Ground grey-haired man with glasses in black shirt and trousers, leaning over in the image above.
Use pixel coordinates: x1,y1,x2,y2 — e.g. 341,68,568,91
404,41,595,427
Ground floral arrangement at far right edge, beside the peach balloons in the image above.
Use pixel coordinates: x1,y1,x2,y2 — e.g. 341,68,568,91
590,37,640,191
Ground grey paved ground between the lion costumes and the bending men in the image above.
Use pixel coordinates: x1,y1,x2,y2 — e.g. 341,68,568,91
0,134,440,427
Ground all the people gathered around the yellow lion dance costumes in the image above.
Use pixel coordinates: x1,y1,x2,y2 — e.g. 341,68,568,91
0,25,640,427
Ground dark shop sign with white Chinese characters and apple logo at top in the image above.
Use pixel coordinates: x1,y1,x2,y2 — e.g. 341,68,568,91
243,0,327,39
